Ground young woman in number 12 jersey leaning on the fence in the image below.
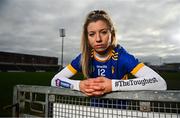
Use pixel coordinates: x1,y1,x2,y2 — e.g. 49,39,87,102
51,10,167,96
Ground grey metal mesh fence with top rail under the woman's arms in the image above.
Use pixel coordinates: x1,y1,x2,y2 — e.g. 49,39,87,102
13,85,180,118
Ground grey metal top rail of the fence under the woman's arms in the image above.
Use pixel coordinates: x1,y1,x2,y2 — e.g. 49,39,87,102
16,85,180,102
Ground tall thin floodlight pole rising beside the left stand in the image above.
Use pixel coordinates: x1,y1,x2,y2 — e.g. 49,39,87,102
59,28,65,70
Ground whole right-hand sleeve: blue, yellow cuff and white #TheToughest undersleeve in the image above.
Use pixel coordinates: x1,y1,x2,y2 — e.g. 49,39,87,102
112,45,167,91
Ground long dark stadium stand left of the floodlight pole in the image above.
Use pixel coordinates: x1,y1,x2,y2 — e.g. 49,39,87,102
0,52,60,72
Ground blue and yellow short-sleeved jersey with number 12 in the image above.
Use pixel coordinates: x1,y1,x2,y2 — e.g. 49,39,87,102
67,45,144,79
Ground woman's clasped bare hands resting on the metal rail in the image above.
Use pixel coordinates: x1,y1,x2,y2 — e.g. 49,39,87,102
79,77,112,96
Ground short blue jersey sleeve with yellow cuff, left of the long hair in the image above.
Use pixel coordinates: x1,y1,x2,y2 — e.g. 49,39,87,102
67,54,82,74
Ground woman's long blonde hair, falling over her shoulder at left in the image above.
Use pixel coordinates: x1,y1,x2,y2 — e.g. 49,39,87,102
81,10,116,78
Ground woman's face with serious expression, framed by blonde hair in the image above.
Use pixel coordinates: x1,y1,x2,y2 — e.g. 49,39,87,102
87,20,111,54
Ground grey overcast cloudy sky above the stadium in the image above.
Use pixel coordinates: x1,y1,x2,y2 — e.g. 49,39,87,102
0,0,180,65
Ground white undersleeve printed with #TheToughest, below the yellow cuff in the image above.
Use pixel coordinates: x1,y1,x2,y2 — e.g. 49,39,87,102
112,65,167,91
